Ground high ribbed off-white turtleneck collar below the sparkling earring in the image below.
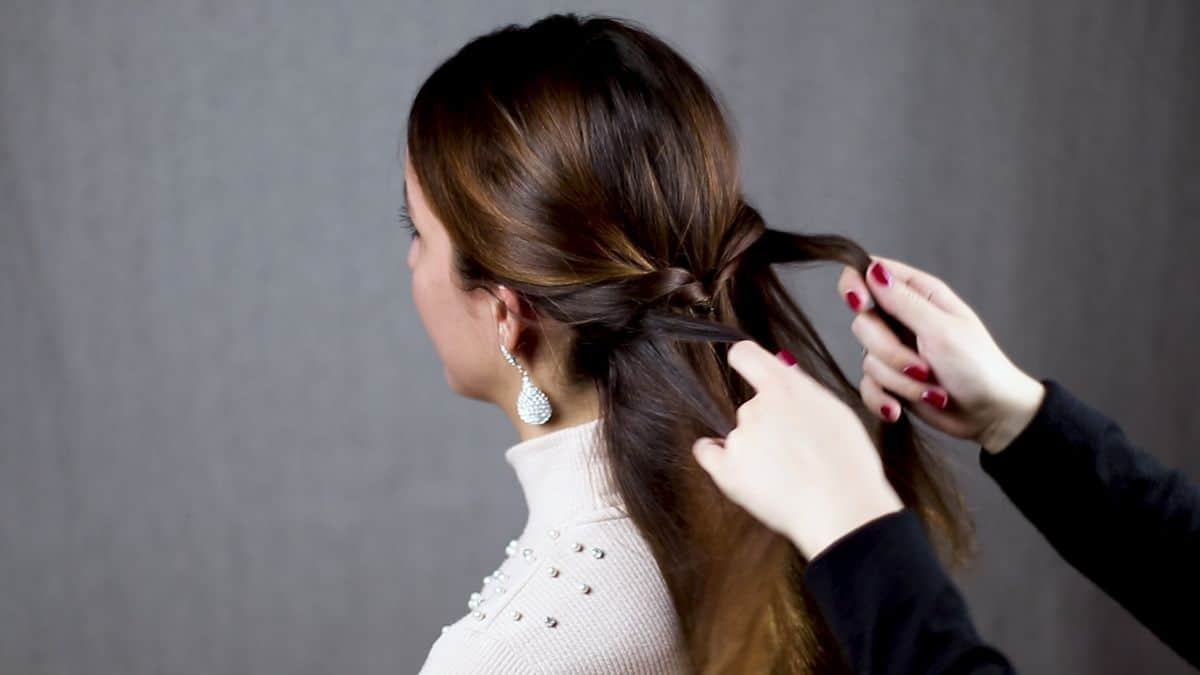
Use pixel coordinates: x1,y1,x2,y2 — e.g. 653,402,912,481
504,418,622,526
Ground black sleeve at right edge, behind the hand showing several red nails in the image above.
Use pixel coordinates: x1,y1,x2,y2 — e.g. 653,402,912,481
979,380,1200,667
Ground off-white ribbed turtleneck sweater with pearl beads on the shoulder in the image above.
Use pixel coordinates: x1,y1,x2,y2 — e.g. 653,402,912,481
421,418,688,675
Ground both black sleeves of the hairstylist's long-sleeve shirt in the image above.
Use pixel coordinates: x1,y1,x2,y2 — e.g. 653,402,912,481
804,378,1200,674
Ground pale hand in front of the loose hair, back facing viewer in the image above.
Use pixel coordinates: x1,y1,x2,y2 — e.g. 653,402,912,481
692,340,904,560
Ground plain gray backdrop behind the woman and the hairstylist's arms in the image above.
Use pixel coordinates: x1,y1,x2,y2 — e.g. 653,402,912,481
0,0,1200,675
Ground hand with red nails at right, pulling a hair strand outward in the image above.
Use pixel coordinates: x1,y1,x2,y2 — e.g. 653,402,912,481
838,256,1045,453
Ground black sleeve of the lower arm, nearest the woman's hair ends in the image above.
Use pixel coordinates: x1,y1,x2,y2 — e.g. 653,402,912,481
804,508,1013,675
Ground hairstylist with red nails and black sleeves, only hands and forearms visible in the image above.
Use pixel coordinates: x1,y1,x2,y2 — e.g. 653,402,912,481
692,258,1200,674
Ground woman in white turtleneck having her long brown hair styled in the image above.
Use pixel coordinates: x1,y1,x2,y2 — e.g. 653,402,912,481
403,14,967,675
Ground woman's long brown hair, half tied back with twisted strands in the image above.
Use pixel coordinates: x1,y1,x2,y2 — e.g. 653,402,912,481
404,14,970,674
